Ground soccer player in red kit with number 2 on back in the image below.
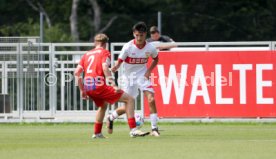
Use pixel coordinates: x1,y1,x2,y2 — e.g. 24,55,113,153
74,34,149,138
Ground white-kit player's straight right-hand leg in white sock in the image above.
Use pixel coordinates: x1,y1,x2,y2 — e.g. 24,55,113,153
144,90,160,137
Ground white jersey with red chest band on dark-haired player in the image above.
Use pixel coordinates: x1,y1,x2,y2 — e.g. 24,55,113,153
119,39,158,76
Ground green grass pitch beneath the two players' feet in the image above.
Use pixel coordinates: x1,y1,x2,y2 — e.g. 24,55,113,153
0,123,276,159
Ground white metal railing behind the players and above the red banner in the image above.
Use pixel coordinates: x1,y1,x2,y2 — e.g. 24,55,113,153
0,41,276,122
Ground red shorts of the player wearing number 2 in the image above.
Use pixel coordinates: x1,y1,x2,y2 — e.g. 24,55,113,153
87,85,124,107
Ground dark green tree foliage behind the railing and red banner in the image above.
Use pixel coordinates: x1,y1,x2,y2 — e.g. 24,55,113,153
0,0,276,42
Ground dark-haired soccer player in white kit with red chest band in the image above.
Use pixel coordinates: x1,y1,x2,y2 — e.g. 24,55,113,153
107,22,160,136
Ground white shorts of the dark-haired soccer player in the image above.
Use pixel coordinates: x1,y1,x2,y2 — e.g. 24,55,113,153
120,76,154,98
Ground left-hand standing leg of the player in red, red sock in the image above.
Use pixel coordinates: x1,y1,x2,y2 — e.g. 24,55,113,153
92,101,107,138
